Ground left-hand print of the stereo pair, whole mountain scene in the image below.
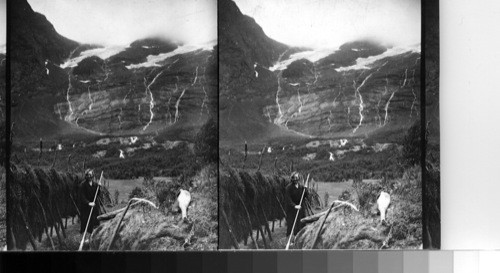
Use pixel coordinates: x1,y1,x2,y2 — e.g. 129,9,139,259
8,0,218,251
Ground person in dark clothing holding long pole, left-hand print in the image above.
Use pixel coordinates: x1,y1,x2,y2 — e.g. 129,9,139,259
78,169,99,234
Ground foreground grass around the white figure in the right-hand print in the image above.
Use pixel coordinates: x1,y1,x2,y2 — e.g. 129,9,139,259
296,167,422,249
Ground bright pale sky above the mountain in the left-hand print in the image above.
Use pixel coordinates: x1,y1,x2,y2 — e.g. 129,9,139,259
28,0,217,45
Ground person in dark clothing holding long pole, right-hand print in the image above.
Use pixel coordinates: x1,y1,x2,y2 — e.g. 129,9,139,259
286,172,307,237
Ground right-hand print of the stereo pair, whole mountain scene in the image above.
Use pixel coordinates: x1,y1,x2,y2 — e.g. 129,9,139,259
218,0,430,249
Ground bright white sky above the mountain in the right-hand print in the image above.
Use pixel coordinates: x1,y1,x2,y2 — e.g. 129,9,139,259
235,0,421,48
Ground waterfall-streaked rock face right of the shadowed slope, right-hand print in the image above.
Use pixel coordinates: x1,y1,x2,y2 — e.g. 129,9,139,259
262,45,420,137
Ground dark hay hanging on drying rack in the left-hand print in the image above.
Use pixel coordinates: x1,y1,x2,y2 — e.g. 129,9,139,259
8,165,106,249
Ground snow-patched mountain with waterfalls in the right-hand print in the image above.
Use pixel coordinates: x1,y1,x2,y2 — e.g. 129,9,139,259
219,0,420,144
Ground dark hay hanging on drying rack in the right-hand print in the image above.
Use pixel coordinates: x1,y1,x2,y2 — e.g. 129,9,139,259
219,167,319,248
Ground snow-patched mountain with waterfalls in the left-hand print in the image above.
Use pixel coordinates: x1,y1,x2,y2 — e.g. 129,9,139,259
9,0,217,140
